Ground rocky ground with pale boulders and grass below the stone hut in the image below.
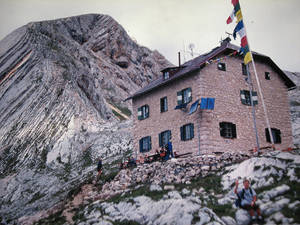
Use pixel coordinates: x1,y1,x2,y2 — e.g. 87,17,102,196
26,150,300,225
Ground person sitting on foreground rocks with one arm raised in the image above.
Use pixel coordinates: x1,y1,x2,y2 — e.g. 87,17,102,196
234,179,262,221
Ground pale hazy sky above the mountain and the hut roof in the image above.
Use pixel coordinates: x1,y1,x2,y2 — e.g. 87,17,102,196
0,0,300,72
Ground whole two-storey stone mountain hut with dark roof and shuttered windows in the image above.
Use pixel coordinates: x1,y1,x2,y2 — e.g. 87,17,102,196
127,39,295,154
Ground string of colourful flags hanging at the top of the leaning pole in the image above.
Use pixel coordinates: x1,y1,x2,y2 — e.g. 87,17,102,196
226,0,252,64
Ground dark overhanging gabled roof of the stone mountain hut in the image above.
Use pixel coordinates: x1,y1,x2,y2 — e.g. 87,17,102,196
125,38,296,101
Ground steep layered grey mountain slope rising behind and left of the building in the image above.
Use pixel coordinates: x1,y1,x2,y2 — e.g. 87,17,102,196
0,15,170,223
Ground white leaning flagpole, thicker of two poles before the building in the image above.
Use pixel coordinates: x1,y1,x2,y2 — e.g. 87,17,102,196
238,1,275,151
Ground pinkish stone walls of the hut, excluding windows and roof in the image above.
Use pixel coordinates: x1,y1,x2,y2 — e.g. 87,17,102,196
132,51,293,155
